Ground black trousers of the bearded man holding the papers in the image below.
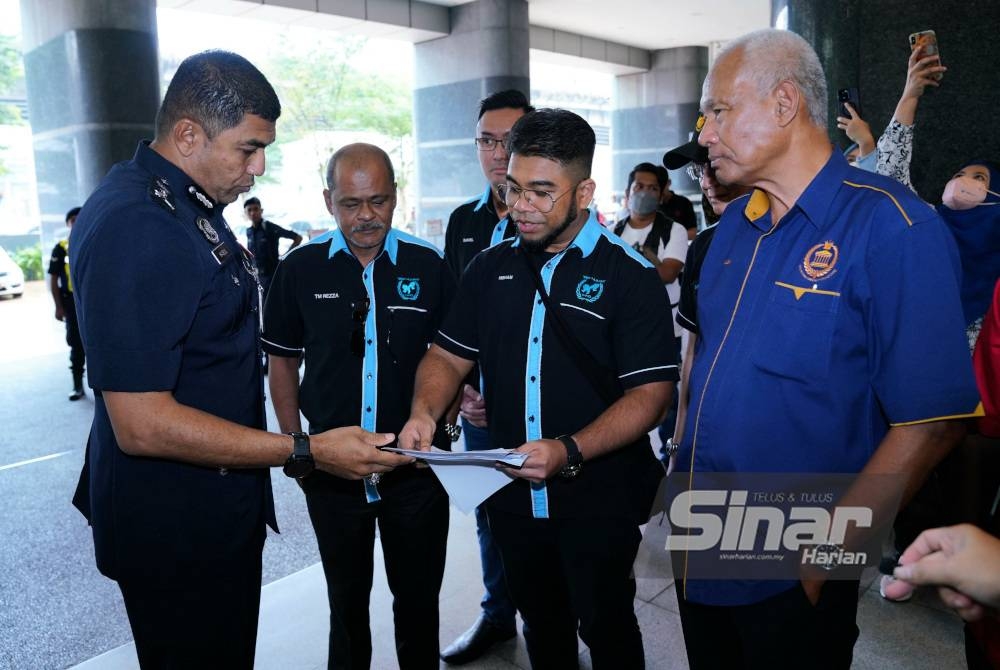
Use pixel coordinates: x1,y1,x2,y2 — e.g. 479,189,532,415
487,507,645,670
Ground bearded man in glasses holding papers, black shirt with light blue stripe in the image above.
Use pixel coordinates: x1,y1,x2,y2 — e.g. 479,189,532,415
399,109,677,670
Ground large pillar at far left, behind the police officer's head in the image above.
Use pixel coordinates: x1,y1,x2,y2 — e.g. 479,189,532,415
21,0,160,249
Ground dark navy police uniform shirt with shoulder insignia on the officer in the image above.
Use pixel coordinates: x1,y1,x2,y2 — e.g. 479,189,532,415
70,143,275,579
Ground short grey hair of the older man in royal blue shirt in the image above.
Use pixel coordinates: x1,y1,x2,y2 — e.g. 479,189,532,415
716,28,826,128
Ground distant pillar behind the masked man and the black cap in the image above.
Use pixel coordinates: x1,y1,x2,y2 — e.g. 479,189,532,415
611,47,708,197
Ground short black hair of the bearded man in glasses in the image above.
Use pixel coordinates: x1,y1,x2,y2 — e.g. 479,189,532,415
508,109,597,179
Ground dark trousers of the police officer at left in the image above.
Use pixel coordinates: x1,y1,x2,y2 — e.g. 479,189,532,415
118,528,264,670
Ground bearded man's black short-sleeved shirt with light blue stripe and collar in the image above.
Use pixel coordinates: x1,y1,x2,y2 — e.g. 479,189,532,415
435,215,677,518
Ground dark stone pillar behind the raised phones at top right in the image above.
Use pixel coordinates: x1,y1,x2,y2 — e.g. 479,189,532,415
787,0,1000,203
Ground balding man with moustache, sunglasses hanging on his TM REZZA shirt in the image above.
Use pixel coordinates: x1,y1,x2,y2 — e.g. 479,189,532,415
262,144,454,669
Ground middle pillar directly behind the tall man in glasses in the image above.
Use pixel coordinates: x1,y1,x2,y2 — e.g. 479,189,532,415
413,0,530,245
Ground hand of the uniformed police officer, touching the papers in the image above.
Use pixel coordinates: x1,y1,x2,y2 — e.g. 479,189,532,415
309,426,414,479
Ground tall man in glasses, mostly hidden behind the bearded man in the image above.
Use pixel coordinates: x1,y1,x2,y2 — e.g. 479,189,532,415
441,89,534,665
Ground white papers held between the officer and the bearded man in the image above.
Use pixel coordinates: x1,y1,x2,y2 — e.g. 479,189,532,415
385,447,528,514
